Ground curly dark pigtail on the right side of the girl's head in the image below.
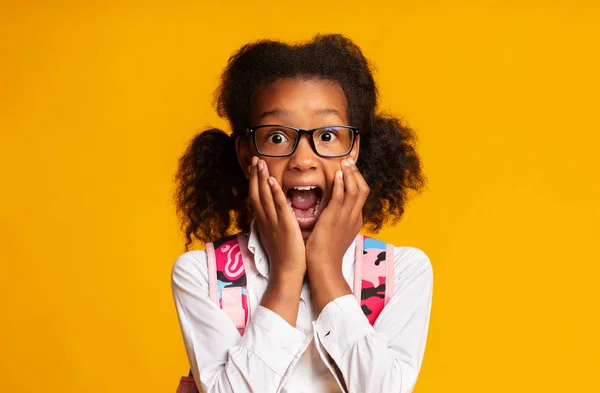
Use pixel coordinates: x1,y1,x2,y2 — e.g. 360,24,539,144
357,114,426,232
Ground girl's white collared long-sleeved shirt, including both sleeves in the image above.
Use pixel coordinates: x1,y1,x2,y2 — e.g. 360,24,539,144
171,223,433,393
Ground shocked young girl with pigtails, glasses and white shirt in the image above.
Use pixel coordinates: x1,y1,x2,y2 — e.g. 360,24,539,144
172,35,433,393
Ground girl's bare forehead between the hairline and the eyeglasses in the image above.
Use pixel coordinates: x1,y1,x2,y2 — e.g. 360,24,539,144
250,78,348,126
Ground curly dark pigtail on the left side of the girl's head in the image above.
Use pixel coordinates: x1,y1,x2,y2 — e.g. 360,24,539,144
175,128,249,250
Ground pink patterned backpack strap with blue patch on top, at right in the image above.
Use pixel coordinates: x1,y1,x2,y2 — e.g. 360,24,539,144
354,234,394,325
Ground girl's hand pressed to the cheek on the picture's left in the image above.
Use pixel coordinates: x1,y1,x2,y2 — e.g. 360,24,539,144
248,157,306,281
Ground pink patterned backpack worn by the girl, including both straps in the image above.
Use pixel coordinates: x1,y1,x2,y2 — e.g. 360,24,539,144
177,233,394,393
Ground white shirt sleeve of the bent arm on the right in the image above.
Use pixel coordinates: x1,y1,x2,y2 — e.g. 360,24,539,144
313,247,433,393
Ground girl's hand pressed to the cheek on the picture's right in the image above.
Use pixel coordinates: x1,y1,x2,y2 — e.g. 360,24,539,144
306,158,370,275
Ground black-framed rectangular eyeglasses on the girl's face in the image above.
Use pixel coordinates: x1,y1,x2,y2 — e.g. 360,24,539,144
246,125,358,158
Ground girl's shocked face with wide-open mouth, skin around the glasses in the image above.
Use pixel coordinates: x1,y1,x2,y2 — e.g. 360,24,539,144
237,79,360,240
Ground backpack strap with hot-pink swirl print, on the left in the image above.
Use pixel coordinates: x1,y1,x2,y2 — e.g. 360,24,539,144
206,234,249,335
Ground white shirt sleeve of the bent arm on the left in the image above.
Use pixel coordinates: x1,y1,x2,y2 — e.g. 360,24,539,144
171,251,306,393
